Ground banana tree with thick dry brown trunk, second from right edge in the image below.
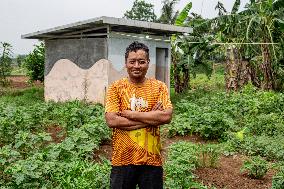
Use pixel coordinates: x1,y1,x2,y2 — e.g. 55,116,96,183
210,0,251,91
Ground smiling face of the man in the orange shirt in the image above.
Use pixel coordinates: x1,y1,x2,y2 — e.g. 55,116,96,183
125,50,149,81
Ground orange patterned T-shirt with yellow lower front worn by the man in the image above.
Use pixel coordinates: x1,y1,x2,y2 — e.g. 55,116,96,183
105,78,172,166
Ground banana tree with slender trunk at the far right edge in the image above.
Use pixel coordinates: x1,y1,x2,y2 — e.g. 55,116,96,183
245,0,284,90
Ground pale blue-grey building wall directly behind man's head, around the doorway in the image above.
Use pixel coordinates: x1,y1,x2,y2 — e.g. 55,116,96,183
108,36,171,86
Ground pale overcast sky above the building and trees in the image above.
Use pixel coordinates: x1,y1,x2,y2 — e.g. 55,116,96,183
0,0,249,55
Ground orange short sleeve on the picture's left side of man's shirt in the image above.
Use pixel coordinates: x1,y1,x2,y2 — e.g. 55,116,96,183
105,84,119,113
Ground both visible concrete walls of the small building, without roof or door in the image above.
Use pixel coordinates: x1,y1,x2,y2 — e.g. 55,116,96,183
44,36,170,104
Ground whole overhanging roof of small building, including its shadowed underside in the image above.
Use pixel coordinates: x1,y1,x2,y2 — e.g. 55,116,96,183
21,16,192,39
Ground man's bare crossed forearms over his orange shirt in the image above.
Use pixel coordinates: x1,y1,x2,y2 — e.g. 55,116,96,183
105,102,173,131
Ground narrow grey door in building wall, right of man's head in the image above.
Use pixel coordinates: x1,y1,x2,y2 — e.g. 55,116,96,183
156,48,168,82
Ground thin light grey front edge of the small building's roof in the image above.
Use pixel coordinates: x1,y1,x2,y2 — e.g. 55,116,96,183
21,16,192,39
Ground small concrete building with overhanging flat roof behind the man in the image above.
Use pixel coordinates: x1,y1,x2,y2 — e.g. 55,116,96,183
22,17,192,104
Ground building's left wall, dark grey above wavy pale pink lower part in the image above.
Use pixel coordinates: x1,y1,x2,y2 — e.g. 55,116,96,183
44,38,109,104
